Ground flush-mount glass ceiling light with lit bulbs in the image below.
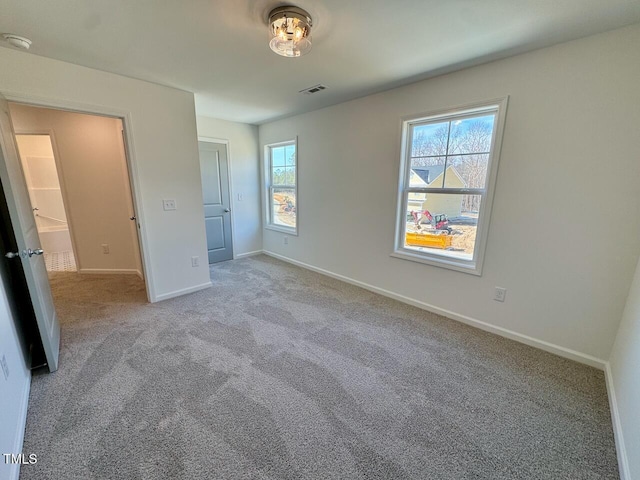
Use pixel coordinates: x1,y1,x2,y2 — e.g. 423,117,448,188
269,6,311,57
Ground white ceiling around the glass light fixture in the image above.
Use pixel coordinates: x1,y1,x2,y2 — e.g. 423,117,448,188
0,0,640,124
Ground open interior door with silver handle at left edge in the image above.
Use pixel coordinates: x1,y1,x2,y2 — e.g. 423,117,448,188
0,95,60,372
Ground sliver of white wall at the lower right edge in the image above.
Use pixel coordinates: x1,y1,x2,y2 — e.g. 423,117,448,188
609,253,640,480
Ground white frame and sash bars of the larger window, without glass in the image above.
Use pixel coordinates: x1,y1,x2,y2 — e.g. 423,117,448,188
391,97,509,276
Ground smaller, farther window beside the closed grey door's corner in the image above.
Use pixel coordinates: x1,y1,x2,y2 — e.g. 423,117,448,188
265,140,298,235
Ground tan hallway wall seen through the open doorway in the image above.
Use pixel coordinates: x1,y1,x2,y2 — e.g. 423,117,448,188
10,103,142,273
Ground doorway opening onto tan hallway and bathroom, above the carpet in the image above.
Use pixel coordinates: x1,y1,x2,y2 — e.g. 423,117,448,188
9,103,144,282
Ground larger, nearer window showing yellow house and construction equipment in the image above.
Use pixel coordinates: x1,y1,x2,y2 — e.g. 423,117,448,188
393,98,507,275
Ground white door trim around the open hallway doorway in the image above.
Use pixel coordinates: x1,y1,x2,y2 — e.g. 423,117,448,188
0,90,154,302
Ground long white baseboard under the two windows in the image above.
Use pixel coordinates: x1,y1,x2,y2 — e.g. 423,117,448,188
262,250,607,370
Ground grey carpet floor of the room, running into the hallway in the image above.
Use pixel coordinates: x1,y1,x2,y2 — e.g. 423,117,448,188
20,256,618,480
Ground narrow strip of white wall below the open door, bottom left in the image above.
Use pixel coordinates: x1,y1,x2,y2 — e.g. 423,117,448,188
0,276,30,479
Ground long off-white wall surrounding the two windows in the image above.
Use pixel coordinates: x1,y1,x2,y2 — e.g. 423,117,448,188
259,21,640,360
